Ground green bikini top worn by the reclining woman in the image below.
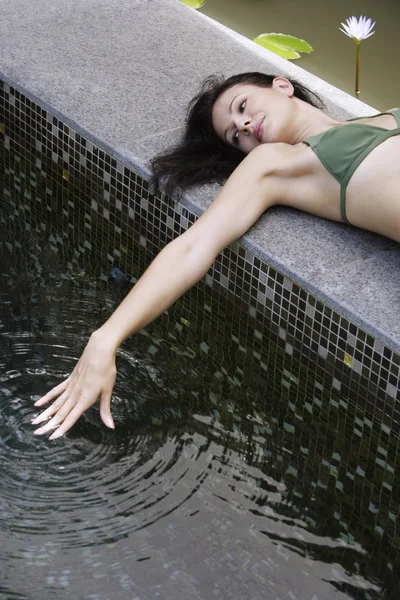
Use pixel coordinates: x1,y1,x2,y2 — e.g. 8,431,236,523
303,108,400,224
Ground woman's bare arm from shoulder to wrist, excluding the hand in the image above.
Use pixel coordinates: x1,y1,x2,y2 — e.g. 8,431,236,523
96,147,274,351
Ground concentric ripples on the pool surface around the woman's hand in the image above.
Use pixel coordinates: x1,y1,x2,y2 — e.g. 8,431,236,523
0,333,212,547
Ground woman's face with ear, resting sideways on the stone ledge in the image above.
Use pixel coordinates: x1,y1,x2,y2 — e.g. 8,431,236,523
212,77,295,154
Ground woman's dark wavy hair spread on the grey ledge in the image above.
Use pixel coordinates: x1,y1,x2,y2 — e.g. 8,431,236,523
151,72,324,196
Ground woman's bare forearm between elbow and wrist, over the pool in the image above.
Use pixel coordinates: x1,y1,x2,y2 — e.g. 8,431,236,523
96,237,215,351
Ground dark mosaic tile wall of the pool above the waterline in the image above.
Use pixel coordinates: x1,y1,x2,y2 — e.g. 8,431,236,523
0,77,400,432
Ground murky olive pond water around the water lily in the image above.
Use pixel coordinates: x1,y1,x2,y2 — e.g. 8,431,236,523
201,0,400,110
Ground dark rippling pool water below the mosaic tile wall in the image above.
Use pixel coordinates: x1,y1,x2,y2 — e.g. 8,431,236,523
0,153,400,600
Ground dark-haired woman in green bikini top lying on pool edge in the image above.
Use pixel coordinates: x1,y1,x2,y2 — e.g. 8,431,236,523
32,73,400,439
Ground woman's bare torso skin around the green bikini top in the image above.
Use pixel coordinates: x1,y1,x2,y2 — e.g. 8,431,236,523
266,114,400,242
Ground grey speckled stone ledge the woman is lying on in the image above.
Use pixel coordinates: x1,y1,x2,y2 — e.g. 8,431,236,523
0,0,400,352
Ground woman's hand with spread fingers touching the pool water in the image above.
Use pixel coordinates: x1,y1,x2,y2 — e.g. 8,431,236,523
32,332,117,440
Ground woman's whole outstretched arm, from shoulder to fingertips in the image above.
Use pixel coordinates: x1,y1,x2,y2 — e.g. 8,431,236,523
32,147,275,439
